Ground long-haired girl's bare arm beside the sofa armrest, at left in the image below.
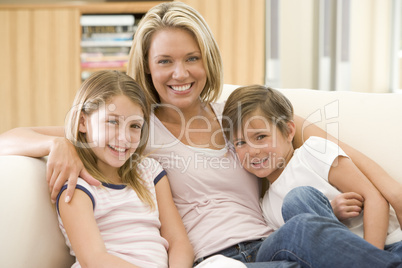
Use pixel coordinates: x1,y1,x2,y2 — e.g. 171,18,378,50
59,190,137,268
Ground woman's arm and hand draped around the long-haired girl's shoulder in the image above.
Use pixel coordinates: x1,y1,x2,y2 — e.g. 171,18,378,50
0,127,100,202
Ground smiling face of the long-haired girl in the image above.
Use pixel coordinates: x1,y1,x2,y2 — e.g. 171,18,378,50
79,95,144,176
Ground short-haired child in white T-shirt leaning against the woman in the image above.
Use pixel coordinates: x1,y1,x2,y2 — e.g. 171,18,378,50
223,86,402,249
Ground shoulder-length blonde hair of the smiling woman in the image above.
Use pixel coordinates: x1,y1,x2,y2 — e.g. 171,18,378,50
127,1,223,104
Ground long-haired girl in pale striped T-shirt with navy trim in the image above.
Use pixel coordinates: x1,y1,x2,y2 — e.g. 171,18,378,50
56,71,194,268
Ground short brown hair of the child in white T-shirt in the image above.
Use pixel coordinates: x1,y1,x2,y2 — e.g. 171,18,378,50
222,85,293,142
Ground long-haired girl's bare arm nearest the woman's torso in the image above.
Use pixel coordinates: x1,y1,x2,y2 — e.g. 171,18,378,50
155,176,194,267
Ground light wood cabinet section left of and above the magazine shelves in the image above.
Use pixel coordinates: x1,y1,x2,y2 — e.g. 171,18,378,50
0,1,161,133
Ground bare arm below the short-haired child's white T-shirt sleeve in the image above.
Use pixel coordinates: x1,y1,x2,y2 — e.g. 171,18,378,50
328,156,389,249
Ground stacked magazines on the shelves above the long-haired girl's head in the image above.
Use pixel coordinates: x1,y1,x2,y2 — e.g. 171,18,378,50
80,14,136,80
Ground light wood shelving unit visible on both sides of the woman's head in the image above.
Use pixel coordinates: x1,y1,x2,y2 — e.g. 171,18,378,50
0,0,265,133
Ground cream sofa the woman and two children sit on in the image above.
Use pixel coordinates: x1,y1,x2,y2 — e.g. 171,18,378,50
0,85,402,268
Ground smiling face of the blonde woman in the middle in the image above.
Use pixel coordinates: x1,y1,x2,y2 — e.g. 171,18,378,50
148,29,207,108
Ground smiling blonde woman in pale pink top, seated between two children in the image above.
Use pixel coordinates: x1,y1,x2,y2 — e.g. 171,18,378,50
0,2,401,267
